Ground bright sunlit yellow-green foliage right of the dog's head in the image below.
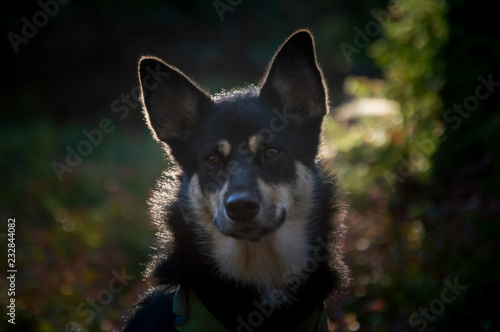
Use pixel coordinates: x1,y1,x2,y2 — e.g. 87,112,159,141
326,0,447,206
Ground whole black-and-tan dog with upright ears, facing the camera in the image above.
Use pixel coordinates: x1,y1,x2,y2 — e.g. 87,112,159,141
125,30,349,332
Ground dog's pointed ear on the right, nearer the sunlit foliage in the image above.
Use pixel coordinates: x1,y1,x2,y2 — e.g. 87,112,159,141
260,30,328,122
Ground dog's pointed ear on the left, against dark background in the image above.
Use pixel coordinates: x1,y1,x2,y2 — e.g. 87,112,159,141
139,57,211,143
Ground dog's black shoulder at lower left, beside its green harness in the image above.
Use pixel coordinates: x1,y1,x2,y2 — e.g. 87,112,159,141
123,287,175,332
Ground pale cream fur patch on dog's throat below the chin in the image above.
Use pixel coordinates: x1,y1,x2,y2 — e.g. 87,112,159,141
200,220,310,307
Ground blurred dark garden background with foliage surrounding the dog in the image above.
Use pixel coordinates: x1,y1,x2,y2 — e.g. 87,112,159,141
0,0,500,332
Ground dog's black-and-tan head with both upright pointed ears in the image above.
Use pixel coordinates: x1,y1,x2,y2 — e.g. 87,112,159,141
139,31,328,241
